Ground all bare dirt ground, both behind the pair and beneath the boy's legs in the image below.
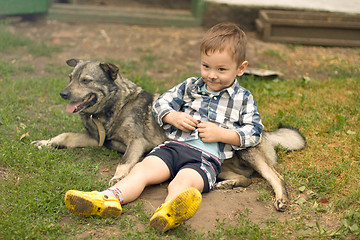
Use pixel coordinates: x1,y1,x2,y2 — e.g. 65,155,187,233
7,18,358,232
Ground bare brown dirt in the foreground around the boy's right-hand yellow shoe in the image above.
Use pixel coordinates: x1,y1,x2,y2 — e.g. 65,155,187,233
136,184,287,233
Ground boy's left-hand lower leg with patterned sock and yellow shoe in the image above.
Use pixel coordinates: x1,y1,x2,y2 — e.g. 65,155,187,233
65,156,170,217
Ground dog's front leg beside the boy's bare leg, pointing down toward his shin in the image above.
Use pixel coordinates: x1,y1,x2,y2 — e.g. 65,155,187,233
109,139,145,186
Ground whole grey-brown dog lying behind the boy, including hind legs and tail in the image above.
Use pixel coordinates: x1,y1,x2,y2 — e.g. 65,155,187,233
31,59,306,211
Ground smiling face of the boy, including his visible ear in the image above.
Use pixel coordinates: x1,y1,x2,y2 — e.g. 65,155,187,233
201,50,248,92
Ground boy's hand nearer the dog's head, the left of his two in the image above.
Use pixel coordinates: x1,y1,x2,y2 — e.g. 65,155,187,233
162,111,198,132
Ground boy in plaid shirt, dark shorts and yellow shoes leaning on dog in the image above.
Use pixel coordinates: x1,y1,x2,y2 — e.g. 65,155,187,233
65,23,263,232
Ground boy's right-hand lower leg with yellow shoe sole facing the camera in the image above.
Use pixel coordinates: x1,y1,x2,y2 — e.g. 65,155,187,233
150,168,204,232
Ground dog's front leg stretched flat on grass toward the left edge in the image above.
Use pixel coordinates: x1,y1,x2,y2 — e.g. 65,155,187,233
31,133,98,149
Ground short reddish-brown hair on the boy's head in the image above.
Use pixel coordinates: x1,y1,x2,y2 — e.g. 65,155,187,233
200,23,247,66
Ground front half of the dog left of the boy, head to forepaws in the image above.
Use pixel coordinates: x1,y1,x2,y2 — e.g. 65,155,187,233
32,59,166,185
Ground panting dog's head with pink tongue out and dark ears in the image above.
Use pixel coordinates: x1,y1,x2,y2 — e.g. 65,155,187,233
60,59,119,114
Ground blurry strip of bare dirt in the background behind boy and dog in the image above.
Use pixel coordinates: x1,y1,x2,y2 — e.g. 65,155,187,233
9,18,359,87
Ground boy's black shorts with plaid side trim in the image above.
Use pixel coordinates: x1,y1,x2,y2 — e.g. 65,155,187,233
148,141,221,192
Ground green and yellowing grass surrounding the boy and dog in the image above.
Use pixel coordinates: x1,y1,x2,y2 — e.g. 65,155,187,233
0,25,360,239
